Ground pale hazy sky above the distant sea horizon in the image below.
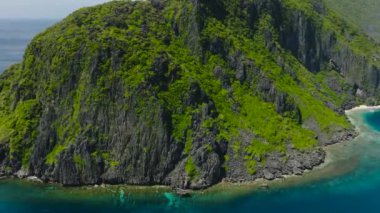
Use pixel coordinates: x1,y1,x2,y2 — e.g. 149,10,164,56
0,0,109,19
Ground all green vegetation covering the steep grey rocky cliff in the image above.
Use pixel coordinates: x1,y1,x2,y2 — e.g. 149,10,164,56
0,0,378,179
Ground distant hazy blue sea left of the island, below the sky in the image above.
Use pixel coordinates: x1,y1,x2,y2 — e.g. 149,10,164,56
0,19,56,73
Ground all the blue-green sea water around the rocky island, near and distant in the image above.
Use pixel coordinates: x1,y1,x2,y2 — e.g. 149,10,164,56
0,21,380,213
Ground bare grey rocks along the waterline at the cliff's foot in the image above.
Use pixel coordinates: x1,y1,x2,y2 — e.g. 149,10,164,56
0,126,358,192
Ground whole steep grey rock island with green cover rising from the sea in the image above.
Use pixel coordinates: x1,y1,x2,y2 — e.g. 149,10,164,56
0,0,380,189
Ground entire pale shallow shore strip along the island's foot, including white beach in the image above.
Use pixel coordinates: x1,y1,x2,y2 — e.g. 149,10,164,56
0,105,374,201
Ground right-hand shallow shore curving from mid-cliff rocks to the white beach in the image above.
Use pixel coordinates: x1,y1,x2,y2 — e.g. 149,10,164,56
182,105,374,196
